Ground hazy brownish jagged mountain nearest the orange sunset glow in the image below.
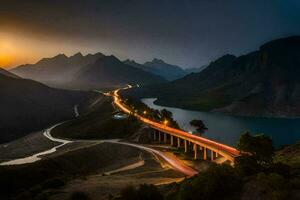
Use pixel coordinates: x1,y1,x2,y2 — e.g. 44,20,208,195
11,53,104,85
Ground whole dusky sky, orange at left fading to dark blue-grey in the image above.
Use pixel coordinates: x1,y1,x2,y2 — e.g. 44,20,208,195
0,0,300,68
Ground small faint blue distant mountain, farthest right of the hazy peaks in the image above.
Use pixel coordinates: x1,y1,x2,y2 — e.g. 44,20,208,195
124,58,187,81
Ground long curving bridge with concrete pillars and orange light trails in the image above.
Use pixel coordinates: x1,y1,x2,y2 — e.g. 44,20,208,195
113,89,240,165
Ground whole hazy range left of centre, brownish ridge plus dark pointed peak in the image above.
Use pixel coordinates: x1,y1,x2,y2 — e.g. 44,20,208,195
11,53,165,89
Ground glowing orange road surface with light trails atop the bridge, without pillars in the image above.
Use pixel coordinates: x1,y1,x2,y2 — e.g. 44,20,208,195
113,86,240,164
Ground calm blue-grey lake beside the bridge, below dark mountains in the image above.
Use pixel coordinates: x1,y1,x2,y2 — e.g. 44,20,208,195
141,98,300,147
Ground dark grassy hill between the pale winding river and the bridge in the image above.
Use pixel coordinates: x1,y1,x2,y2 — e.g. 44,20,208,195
52,95,140,139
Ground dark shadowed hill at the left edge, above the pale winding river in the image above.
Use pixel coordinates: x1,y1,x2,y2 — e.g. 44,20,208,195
0,74,93,143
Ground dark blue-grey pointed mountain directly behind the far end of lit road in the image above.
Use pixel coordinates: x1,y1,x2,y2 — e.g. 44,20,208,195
72,56,165,88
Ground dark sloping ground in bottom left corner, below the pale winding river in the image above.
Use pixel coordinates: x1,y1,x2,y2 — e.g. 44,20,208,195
0,143,140,200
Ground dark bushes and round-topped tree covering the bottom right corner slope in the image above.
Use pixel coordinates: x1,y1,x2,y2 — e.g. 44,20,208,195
121,132,300,200
